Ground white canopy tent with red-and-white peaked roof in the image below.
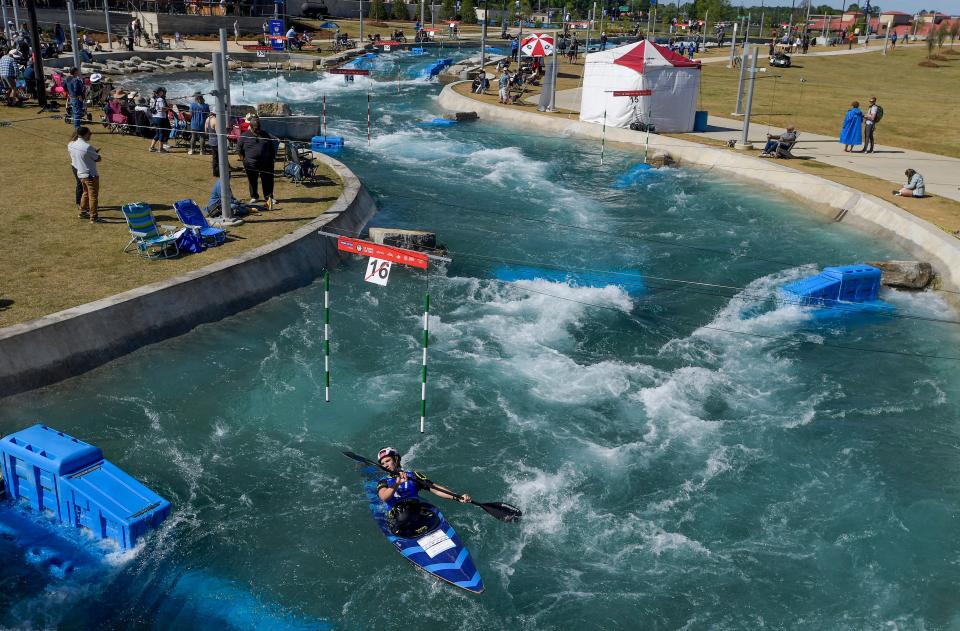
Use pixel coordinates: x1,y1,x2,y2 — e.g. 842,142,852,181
580,40,700,132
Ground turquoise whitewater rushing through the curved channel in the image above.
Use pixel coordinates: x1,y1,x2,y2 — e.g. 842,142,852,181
0,56,960,629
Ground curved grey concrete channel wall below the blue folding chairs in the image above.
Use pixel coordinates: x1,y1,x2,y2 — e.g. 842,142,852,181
0,154,377,397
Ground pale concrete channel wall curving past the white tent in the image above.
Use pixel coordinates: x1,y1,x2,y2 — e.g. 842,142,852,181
439,82,960,290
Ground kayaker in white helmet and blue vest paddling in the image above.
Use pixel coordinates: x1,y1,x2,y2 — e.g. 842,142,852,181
377,447,470,536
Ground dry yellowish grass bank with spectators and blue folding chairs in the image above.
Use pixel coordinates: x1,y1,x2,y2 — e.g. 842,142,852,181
0,115,343,327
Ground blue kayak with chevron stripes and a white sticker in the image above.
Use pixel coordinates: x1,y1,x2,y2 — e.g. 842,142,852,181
362,467,483,594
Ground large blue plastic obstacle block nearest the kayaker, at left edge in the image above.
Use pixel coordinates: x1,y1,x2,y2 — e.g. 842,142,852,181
0,424,170,548
